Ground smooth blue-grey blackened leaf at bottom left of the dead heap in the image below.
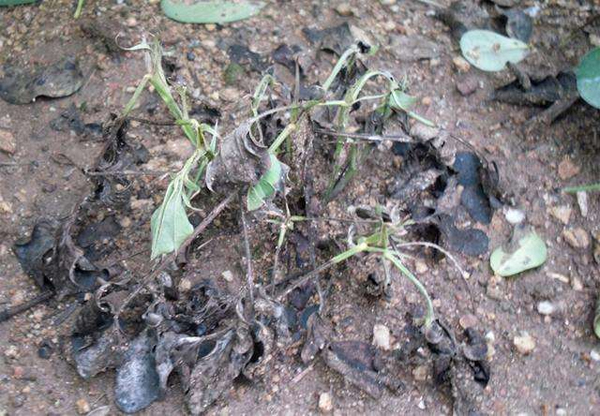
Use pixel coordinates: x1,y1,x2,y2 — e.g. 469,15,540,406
115,330,160,413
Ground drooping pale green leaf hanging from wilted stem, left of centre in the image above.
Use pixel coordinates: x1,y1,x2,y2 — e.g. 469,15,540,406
150,180,194,259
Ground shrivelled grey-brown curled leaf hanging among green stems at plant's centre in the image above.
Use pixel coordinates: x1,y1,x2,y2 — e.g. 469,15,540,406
206,122,270,190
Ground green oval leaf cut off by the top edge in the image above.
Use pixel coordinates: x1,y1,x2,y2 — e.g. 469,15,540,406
161,0,264,23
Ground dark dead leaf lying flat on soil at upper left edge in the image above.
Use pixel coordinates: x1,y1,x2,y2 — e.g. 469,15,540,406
0,57,84,104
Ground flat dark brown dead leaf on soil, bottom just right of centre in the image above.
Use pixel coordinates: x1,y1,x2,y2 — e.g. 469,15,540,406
323,341,402,399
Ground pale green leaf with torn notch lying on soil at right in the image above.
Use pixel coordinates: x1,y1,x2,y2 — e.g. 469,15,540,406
490,230,548,276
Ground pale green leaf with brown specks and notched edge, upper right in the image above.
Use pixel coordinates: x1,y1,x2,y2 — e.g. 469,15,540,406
460,30,529,71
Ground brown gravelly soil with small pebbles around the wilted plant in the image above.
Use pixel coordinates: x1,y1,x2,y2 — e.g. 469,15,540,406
0,0,600,415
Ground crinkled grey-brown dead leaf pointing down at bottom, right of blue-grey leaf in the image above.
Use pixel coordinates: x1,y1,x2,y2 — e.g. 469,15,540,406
186,328,252,415
